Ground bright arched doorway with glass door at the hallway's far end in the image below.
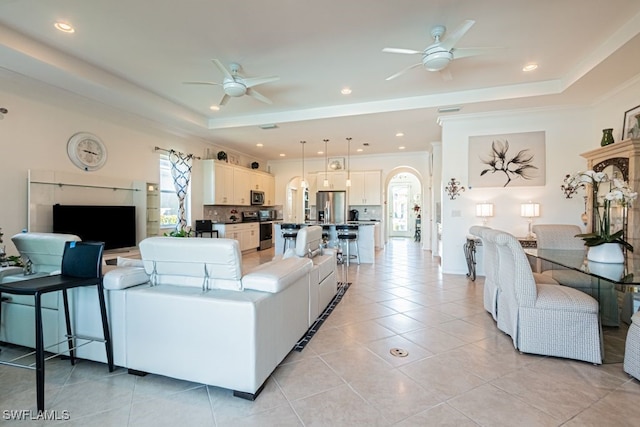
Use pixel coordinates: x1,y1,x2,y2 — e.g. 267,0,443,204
385,167,429,246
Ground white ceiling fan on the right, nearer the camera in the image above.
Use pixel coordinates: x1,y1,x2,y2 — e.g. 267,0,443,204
382,20,496,80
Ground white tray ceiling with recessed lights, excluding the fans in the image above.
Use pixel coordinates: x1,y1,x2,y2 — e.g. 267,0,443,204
0,0,640,159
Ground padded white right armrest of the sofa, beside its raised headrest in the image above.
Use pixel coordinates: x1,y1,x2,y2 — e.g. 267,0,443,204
242,257,313,293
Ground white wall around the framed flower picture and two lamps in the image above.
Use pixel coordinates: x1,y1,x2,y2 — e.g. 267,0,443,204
442,77,640,274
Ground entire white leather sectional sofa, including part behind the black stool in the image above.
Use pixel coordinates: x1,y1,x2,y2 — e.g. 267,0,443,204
0,232,330,399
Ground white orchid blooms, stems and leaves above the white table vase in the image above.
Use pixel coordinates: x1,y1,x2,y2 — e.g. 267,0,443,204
560,170,638,252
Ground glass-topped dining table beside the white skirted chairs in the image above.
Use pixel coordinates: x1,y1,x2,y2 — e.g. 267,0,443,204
524,248,640,363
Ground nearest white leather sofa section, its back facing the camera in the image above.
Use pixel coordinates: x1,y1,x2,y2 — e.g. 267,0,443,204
100,237,313,399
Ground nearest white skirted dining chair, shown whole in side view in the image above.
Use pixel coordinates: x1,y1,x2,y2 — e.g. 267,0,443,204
487,231,602,364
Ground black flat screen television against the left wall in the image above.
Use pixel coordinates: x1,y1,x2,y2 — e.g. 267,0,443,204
53,205,137,250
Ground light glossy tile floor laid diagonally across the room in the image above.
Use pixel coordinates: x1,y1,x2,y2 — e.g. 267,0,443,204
0,239,640,426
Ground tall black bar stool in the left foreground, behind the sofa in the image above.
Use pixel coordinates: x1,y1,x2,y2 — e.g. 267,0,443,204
0,242,114,411
